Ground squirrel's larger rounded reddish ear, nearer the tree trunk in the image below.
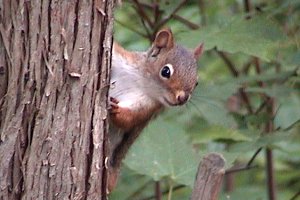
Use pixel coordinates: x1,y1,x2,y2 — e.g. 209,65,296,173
153,28,174,49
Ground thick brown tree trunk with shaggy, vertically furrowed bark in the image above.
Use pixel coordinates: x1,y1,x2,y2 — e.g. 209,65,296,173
0,0,114,200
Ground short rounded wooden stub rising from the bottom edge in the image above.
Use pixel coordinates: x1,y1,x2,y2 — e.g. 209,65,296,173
191,153,225,200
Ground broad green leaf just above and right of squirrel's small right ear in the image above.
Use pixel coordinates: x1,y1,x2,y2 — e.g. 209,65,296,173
181,16,286,62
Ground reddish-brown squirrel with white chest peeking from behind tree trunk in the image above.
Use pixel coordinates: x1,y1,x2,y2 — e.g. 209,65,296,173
108,28,203,192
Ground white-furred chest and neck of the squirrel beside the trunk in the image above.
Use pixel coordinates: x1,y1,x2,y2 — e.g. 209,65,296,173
109,43,156,115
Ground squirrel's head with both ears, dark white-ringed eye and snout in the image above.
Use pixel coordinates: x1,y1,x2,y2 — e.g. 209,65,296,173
145,28,204,106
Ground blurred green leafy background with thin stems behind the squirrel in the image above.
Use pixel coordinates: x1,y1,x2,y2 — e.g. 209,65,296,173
110,0,300,200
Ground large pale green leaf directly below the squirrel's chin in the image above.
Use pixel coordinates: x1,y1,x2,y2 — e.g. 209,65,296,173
125,117,200,186
